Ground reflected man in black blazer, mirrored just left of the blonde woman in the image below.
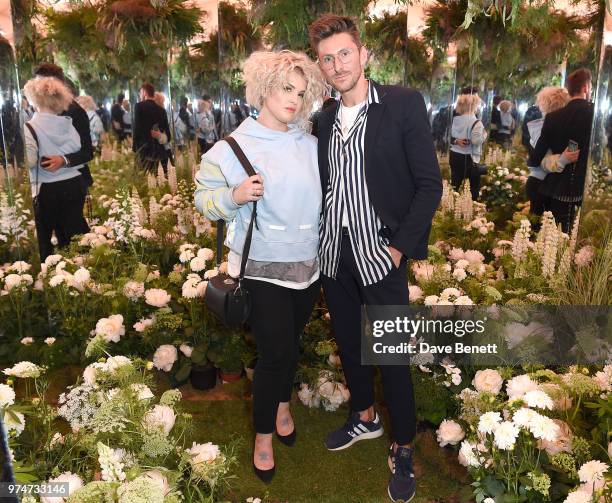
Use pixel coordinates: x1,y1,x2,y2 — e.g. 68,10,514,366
132,84,170,173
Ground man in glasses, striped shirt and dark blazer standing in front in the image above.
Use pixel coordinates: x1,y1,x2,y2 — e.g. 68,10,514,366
309,14,442,501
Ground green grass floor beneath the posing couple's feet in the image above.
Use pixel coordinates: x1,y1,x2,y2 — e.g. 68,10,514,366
183,381,470,503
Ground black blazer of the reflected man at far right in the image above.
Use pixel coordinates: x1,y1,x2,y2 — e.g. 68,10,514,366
529,99,593,197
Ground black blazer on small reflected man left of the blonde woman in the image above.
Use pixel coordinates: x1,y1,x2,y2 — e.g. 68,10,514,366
132,99,170,159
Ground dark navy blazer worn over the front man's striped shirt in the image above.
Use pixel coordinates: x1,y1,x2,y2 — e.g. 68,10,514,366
318,83,442,260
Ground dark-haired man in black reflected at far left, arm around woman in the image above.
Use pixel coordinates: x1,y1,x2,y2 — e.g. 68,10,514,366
34,63,94,188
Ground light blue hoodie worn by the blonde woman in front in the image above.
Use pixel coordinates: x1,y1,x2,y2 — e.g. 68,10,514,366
195,117,322,262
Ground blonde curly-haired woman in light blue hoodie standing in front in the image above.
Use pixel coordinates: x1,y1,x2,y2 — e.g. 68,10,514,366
195,51,325,482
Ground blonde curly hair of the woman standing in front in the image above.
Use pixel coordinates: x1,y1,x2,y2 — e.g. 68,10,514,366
242,50,325,120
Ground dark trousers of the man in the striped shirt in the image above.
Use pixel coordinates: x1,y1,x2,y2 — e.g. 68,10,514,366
322,236,416,445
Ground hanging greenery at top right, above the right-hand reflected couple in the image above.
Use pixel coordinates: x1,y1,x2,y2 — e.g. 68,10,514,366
424,0,595,95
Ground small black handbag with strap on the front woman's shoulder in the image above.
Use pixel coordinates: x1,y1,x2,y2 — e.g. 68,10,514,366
204,136,257,327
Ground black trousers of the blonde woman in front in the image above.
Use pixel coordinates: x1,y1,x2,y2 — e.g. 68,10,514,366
245,279,321,433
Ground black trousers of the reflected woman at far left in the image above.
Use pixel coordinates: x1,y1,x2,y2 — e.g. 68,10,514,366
34,176,89,261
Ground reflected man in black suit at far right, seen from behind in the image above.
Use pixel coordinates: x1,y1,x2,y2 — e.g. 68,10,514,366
529,68,593,232
